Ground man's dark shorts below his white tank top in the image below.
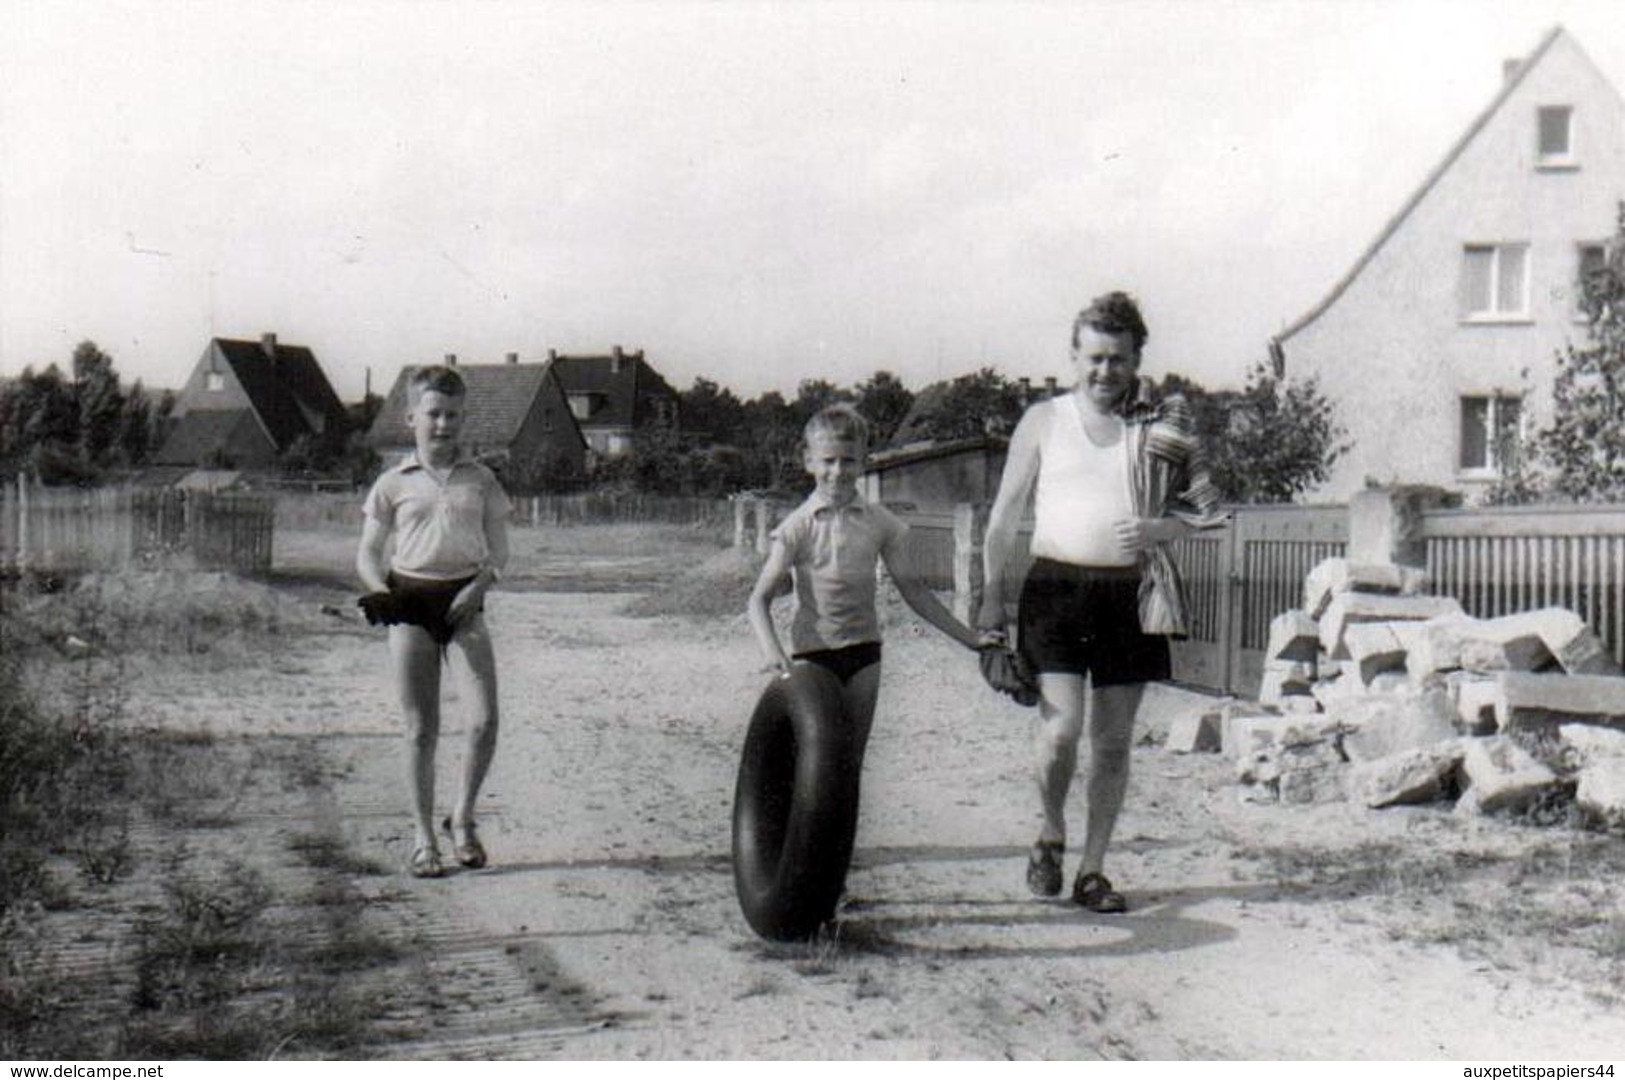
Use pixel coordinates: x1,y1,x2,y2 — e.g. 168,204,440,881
1016,559,1173,689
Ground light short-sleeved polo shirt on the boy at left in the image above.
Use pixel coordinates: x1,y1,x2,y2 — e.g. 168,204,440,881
362,455,509,581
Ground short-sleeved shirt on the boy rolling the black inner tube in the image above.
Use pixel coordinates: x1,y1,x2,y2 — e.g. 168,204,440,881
774,492,908,654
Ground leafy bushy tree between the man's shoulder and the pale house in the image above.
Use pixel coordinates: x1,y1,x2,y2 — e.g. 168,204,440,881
1157,364,1350,503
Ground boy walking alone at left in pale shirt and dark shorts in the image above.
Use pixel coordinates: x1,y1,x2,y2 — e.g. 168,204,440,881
356,365,509,877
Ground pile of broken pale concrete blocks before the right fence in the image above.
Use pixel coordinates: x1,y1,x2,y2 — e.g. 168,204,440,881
1167,559,1625,825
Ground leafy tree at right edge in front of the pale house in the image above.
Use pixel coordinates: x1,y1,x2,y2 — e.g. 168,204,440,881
1490,201,1625,502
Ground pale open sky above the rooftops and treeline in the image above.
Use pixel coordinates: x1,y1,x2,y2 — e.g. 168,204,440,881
0,0,1625,400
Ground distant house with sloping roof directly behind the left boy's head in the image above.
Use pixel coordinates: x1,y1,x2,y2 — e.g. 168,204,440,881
367,352,587,494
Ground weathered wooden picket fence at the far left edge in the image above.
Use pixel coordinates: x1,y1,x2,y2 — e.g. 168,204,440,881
0,481,275,573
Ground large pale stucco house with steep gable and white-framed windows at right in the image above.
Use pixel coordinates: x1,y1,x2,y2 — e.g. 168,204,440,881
1271,28,1625,499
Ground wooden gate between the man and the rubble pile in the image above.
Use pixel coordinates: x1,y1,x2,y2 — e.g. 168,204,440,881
1173,505,1349,697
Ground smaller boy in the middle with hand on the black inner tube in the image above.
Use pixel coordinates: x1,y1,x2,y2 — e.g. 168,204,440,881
748,404,977,762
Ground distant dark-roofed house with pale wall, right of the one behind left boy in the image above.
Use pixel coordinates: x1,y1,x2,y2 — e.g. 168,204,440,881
548,346,678,458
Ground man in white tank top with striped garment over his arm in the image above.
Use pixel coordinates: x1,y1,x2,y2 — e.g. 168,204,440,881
977,292,1222,913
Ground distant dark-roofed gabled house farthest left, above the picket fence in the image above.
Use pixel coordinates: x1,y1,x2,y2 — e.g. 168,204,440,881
153,333,348,469
